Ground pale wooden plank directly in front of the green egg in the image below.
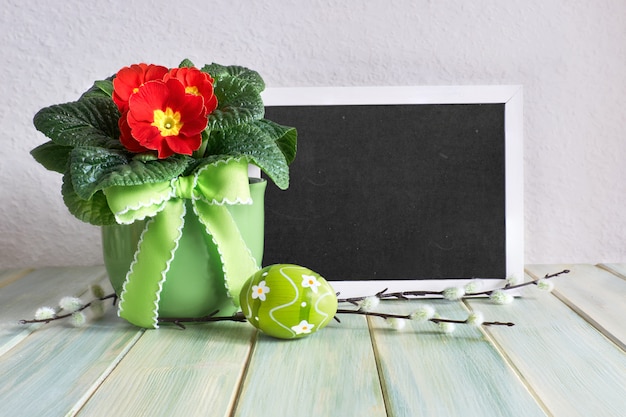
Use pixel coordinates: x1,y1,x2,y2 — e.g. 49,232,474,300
234,316,387,417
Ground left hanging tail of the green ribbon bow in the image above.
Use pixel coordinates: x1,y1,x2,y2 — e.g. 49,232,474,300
118,200,185,328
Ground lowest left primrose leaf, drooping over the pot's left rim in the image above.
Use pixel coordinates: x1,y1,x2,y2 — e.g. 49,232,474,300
61,174,116,226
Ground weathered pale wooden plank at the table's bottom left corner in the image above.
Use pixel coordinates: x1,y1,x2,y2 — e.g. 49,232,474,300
0,314,138,417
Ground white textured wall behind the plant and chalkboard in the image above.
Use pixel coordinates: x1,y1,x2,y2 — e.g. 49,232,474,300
0,0,626,268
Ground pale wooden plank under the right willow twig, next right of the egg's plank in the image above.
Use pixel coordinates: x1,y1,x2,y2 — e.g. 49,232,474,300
372,300,545,417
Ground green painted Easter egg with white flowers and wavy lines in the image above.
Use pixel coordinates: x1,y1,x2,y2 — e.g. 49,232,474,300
239,264,337,339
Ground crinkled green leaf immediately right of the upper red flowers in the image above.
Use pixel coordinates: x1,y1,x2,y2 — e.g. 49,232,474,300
208,78,265,130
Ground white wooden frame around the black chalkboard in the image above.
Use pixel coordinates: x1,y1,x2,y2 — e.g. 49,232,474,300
251,85,524,298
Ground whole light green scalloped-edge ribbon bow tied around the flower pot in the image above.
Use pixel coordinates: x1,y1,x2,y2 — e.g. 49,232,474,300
104,158,258,328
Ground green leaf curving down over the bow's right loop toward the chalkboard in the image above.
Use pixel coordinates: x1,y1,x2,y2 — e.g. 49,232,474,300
209,124,289,190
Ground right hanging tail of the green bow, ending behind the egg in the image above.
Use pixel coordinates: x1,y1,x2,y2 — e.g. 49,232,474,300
194,200,259,307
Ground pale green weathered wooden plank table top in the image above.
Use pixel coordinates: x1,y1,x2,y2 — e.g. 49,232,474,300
0,264,626,417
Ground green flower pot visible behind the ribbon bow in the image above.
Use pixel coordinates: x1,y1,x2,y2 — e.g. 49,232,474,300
102,178,267,318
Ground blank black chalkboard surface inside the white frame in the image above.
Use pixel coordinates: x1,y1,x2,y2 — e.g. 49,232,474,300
263,88,521,294
